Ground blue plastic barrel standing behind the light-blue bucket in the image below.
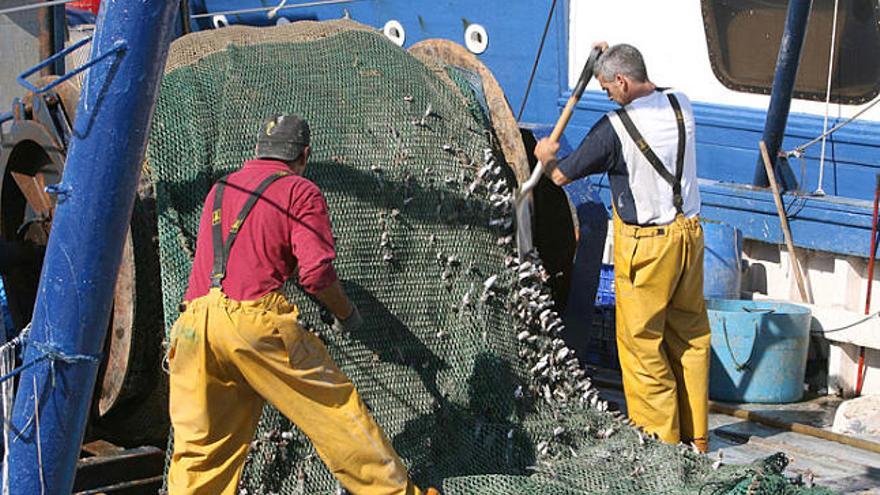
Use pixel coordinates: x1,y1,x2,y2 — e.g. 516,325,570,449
702,221,742,299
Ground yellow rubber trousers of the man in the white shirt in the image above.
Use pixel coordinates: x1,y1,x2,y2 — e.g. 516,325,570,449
614,214,710,451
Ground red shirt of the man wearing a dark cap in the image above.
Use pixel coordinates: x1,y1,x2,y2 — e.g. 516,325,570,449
184,160,336,301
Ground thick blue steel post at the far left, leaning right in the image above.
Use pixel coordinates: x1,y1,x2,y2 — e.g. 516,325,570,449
5,0,178,495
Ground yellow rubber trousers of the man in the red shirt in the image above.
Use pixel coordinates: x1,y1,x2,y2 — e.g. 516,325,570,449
168,289,421,495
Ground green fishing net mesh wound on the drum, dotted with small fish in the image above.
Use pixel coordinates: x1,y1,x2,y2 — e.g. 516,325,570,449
148,22,832,494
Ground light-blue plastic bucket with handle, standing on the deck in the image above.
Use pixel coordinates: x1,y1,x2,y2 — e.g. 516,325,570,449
706,299,810,404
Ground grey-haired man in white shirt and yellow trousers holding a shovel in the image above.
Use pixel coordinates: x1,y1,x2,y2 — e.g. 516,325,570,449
535,42,710,452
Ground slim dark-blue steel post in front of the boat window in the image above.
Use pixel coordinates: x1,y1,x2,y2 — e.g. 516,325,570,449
752,0,812,187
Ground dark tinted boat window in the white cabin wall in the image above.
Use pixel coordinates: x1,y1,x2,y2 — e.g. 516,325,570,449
701,0,880,104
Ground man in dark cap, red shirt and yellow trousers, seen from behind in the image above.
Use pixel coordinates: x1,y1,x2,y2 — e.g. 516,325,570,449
168,115,437,495
